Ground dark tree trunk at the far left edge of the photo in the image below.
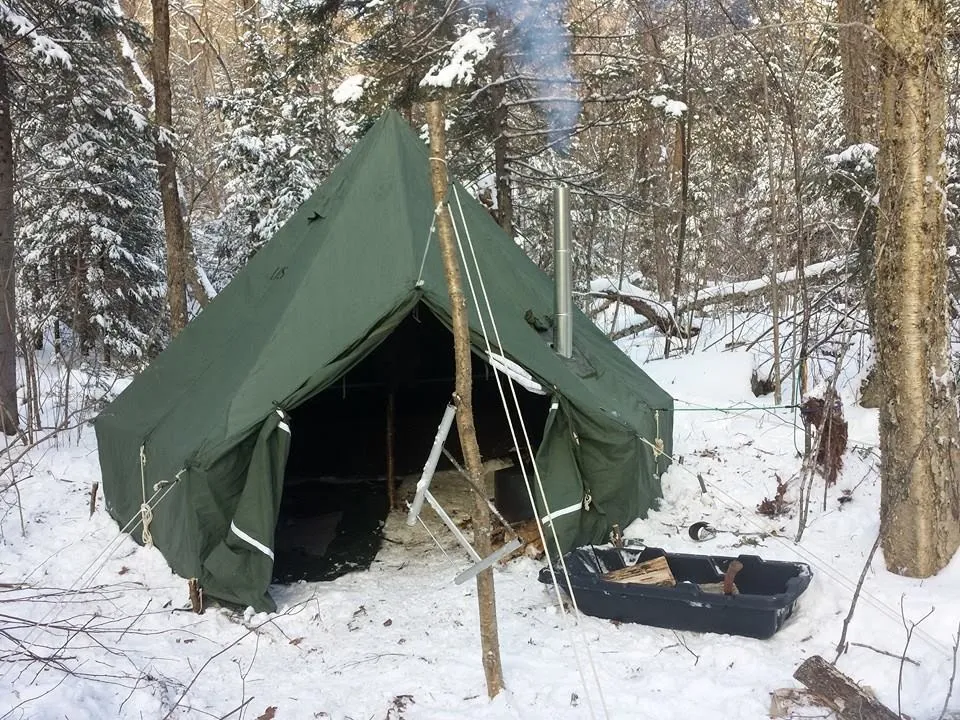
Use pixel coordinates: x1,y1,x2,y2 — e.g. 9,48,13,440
0,47,20,435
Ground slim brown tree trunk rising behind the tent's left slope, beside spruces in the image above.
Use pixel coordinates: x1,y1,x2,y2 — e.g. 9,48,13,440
151,0,187,336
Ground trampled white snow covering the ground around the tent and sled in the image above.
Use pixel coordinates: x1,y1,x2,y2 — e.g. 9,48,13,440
0,345,960,720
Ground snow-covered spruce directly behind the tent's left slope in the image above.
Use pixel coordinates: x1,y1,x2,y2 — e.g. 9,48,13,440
204,2,343,287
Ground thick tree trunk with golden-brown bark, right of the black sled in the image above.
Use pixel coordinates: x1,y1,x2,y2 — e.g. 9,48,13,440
876,0,960,577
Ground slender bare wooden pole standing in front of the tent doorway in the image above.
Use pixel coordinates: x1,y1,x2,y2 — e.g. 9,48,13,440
427,101,503,698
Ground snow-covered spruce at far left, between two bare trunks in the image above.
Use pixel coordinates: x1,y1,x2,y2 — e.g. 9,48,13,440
14,0,163,364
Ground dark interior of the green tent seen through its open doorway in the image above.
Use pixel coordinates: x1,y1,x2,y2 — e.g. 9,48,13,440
274,304,550,582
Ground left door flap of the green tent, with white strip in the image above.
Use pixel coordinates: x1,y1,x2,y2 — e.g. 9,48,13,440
200,408,290,612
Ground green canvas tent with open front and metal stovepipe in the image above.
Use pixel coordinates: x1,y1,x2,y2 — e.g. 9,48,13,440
95,111,673,610
